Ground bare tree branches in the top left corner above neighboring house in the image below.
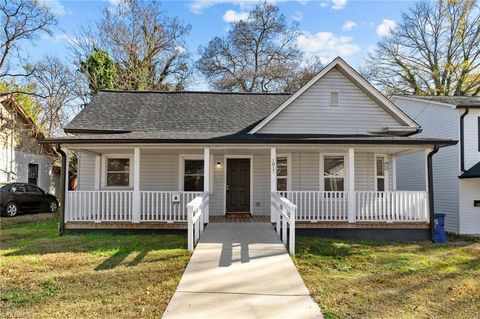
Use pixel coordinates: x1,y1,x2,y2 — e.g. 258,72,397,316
0,0,57,80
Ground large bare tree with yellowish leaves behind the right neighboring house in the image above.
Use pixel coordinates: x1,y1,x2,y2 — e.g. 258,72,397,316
363,0,480,95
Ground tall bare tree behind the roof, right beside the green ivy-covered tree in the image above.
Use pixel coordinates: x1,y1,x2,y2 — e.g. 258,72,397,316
72,0,190,90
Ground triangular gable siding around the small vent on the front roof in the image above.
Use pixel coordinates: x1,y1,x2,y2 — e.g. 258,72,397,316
259,69,401,134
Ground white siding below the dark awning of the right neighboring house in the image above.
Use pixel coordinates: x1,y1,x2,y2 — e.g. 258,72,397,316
459,179,480,235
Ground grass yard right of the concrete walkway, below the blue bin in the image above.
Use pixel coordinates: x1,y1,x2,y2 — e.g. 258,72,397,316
295,236,480,319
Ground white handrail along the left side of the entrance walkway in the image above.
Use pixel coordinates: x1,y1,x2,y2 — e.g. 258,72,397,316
187,192,209,252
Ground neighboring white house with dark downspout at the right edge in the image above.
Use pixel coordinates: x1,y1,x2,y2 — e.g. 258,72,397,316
392,96,480,234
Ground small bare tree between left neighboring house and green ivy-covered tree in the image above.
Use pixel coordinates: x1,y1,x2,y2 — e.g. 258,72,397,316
31,56,79,137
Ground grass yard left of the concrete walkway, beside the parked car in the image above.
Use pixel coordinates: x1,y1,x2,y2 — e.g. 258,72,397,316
0,214,189,319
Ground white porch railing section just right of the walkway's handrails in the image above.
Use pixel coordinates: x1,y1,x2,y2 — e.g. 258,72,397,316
278,191,348,222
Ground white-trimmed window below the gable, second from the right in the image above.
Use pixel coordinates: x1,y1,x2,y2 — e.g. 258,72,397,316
323,155,345,192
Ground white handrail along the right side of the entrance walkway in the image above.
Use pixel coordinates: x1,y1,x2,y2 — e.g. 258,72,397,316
271,192,297,256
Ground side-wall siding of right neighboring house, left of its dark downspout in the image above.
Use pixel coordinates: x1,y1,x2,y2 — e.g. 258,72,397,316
394,98,460,233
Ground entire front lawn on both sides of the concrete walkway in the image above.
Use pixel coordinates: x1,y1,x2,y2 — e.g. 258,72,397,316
0,214,480,319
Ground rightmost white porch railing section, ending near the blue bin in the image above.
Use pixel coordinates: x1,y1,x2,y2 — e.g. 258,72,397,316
355,191,429,222
